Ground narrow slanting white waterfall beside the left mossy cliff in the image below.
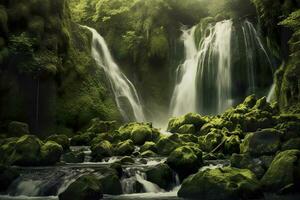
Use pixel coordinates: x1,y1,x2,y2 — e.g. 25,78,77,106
83,26,145,121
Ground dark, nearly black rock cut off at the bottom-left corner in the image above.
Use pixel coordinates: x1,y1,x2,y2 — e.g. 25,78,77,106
0,165,19,192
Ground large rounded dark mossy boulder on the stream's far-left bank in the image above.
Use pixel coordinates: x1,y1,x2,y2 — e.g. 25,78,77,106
10,135,42,166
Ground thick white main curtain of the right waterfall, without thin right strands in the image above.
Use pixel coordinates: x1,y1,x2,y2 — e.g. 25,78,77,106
170,20,233,116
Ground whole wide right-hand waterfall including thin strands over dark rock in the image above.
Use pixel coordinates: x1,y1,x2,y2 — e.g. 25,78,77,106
170,20,273,116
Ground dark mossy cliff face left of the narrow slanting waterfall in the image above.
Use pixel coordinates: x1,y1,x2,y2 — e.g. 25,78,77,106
0,0,120,135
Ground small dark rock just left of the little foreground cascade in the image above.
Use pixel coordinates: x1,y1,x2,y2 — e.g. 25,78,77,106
99,173,123,195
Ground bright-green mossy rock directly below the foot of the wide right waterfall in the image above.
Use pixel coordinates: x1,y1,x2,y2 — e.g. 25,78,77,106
167,113,207,133
